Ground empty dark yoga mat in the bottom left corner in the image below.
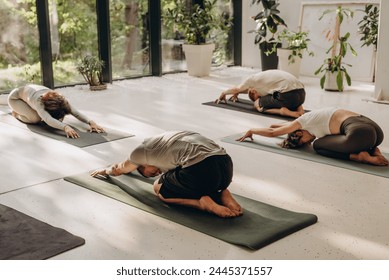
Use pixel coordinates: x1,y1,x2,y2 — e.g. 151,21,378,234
0,204,85,260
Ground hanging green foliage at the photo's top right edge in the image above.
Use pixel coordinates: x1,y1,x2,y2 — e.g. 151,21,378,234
358,4,380,50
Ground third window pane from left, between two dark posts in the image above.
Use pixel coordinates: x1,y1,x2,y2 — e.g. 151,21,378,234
110,0,150,79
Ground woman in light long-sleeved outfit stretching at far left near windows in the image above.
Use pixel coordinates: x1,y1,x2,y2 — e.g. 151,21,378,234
8,84,104,138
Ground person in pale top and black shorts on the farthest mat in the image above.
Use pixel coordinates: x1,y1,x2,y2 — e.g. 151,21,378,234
215,70,305,118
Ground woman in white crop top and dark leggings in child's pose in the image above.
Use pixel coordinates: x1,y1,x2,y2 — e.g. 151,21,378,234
237,108,388,166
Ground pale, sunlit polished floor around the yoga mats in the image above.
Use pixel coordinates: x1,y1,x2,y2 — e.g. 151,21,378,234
0,67,389,260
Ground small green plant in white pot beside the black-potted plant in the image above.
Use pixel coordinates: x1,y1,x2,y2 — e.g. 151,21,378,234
277,29,313,78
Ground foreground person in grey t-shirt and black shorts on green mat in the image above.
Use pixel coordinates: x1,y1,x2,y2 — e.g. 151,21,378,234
91,131,243,218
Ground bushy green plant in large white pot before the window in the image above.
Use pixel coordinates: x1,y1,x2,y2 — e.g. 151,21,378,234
164,0,230,77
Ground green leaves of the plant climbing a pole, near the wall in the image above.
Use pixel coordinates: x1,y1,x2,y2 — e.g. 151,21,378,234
315,6,357,91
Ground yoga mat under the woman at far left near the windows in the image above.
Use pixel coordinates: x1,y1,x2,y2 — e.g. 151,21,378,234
0,114,134,148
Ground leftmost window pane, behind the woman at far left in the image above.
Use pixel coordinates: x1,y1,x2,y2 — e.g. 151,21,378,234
0,0,41,92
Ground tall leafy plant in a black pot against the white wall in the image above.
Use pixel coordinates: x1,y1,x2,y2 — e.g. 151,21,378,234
249,0,287,71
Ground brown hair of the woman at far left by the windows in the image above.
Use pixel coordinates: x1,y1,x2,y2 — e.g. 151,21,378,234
42,91,71,120
